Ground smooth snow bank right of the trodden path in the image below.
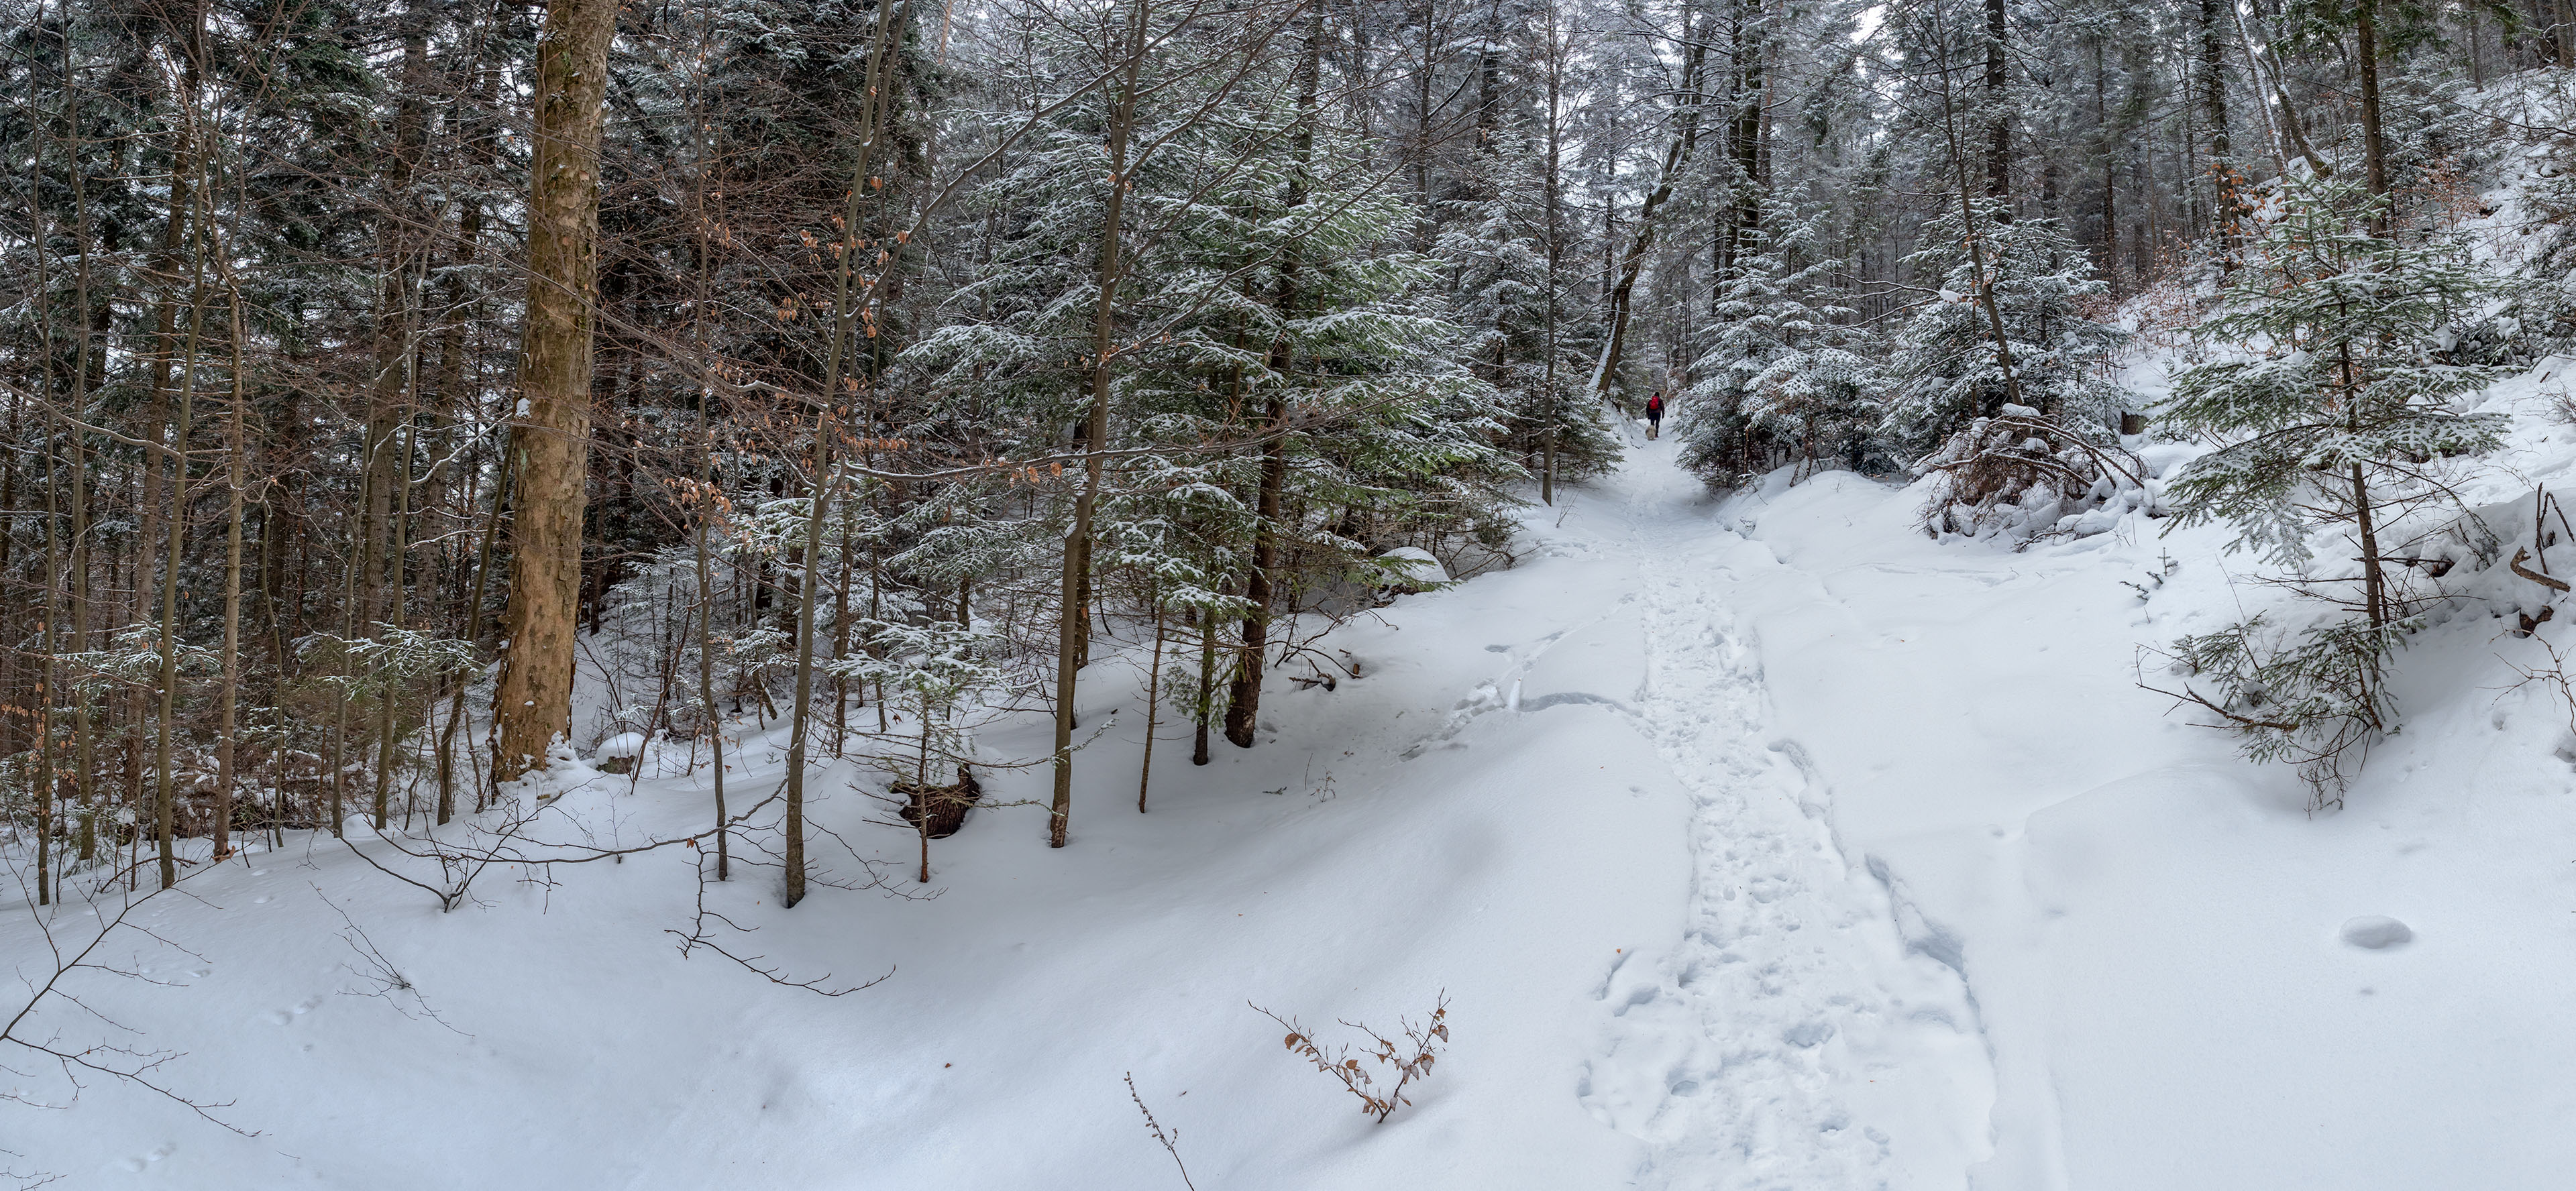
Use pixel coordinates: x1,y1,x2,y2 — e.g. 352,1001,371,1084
1723,455,2576,1191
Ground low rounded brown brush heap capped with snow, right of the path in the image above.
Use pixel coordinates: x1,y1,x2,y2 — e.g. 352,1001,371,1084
1914,404,2156,541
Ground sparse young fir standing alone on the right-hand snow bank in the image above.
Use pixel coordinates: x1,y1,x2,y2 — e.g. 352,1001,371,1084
2161,180,2504,807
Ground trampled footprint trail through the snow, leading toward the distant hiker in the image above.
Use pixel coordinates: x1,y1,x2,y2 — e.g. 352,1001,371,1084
1579,443,1994,1188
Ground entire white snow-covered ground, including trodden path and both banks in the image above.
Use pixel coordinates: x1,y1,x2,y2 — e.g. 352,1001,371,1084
15,419,2576,1191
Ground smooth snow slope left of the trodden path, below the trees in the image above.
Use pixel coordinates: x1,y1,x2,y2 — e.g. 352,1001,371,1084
0,486,1690,1191
